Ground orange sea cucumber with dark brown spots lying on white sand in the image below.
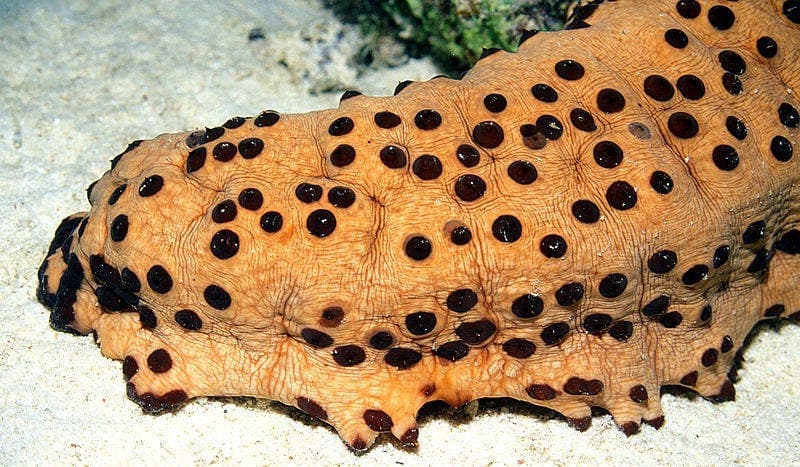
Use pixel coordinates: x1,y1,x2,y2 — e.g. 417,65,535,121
39,0,800,450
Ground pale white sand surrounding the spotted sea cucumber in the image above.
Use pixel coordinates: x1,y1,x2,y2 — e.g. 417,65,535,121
0,0,800,465
